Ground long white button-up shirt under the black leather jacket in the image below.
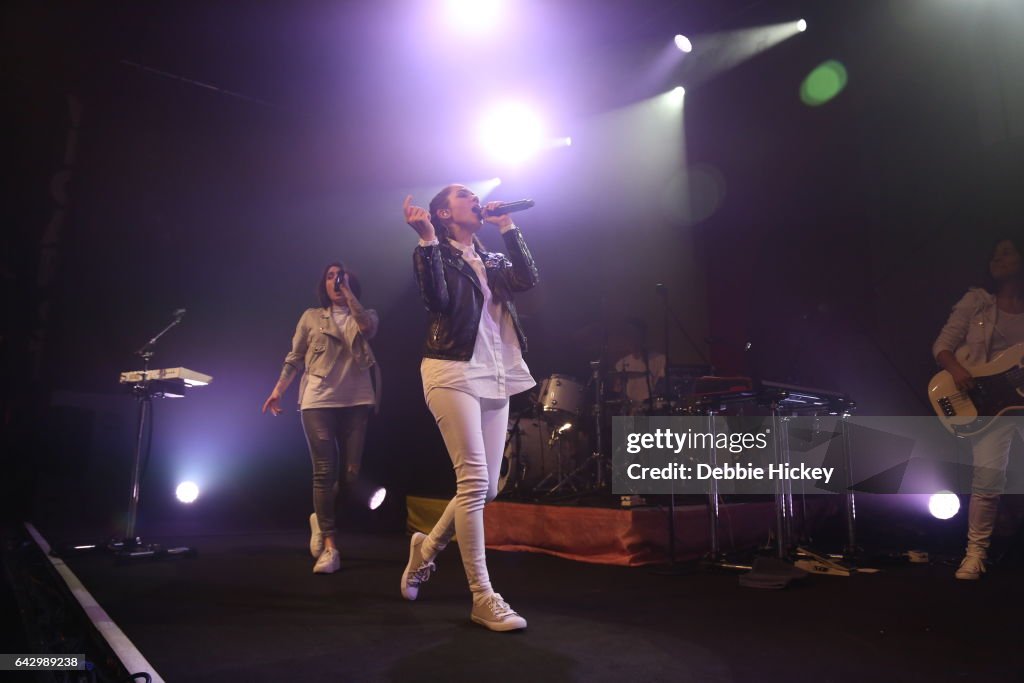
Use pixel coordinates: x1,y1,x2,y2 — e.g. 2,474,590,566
420,235,537,398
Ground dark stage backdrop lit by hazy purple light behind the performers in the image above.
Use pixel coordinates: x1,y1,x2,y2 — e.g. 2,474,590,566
4,2,1024,529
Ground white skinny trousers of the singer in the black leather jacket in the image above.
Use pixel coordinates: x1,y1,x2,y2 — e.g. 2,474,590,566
421,388,509,596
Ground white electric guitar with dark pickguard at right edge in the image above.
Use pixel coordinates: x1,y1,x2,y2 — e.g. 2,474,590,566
928,343,1024,436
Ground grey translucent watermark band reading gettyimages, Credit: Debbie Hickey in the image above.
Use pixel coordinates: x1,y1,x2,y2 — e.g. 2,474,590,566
612,416,1024,495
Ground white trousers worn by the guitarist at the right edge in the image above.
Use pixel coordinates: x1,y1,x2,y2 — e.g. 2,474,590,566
967,418,1024,557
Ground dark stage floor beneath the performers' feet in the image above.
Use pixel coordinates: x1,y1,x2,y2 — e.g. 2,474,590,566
24,529,1024,683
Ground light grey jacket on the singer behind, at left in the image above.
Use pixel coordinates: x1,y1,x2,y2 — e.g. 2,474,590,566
285,308,382,410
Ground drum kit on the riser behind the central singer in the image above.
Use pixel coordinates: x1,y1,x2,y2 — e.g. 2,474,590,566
498,360,708,499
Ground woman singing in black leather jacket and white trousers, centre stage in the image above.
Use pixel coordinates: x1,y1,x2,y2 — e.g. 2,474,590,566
401,185,538,631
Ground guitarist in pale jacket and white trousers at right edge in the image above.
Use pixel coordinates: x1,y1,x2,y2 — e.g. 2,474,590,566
932,239,1024,580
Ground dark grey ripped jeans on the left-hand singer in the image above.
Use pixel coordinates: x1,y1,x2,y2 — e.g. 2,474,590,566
302,405,372,536
